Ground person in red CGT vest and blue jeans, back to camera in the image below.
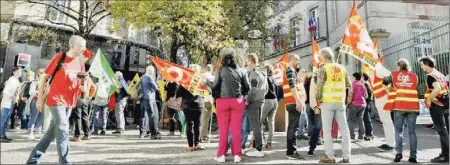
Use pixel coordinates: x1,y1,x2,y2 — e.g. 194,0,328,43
383,59,420,163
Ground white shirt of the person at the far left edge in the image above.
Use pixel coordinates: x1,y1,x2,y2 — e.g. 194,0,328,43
1,76,21,108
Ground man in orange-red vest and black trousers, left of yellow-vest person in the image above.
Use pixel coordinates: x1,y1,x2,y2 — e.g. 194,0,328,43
283,54,304,159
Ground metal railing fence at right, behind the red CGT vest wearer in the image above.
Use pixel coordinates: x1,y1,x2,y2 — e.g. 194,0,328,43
381,20,450,94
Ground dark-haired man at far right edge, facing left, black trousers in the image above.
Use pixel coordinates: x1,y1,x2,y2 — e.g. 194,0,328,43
419,56,449,163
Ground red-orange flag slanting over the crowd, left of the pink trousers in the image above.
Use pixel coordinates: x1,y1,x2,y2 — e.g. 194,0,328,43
150,56,209,96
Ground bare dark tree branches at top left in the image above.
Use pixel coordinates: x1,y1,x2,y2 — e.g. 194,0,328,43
27,0,111,38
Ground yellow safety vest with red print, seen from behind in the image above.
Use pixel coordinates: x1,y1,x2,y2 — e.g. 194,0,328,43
322,63,347,103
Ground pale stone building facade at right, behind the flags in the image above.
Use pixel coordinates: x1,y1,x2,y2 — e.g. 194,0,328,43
266,0,449,74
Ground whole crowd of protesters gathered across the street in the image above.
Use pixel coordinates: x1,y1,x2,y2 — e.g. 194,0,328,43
0,36,449,164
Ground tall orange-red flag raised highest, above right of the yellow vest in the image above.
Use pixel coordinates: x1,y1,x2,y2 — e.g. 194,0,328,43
340,0,378,69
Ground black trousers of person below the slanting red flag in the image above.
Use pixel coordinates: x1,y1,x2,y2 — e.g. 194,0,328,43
184,109,202,147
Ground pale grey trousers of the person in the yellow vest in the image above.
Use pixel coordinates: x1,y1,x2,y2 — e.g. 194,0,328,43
320,103,351,159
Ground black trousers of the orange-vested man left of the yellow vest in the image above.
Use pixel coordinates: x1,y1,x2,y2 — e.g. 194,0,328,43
286,104,300,155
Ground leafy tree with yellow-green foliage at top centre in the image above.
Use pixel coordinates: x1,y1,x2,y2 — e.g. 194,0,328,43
110,0,231,63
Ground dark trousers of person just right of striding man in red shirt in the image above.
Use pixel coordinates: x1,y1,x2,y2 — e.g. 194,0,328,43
71,100,91,137
